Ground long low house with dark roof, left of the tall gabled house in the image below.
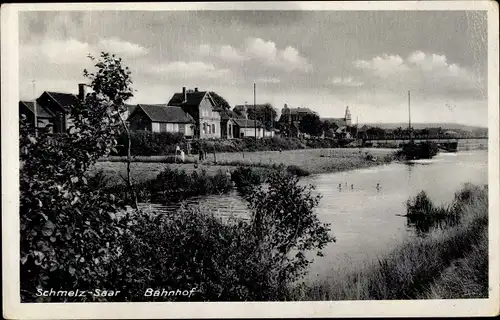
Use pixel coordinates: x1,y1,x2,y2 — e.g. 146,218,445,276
127,104,195,137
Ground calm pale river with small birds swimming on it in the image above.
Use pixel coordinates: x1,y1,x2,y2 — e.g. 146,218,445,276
135,150,488,280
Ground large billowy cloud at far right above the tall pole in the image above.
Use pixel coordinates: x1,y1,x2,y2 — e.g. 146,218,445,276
353,51,486,99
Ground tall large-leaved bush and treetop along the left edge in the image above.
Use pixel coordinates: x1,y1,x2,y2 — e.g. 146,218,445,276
20,53,132,301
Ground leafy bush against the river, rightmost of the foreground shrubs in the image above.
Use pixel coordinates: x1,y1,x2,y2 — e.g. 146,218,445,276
245,171,335,298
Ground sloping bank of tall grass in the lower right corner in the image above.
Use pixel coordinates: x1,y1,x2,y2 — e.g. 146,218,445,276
292,186,488,300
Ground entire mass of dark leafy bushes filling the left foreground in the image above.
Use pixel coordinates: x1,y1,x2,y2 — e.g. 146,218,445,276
20,53,333,302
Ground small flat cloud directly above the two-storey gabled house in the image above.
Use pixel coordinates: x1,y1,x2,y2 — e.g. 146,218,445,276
148,61,231,79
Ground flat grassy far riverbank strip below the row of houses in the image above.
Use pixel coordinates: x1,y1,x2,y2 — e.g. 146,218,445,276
92,148,394,181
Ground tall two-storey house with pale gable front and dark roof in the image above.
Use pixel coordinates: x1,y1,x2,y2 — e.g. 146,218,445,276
167,87,222,139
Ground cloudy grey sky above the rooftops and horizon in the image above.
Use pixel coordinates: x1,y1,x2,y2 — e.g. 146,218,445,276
19,11,488,126
